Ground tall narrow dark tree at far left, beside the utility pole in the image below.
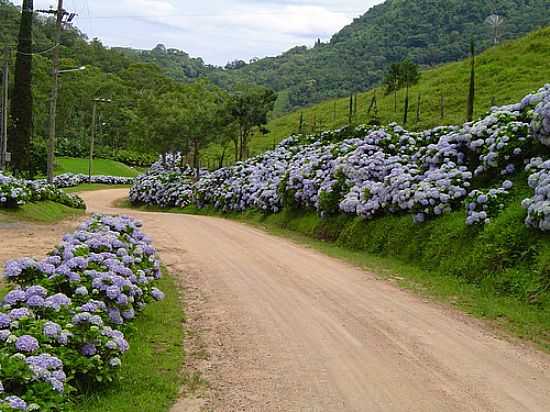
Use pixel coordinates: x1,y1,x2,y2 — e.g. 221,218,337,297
8,0,34,175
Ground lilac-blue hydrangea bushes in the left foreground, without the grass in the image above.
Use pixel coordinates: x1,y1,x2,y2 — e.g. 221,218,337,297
0,215,164,410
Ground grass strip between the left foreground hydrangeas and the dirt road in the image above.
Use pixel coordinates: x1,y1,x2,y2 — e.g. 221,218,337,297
77,271,187,412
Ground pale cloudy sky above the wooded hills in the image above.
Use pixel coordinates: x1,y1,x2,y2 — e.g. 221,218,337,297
14,0,383,65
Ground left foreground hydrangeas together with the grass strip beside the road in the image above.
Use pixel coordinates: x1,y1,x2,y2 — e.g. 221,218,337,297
0,215,177,412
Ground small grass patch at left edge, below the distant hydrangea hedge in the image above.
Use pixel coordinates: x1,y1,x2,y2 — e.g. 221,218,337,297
0,201,84,223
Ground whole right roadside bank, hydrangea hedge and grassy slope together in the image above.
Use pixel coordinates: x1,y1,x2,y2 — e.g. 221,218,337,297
130,85,550,334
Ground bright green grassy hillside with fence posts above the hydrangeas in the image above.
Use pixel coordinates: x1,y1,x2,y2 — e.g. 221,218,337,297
247,27,550,154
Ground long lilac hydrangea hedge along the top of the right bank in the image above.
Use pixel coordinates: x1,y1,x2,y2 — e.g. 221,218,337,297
131,85,550,230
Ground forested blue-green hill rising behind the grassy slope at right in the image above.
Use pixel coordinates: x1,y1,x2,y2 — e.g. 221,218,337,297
209,0,550,109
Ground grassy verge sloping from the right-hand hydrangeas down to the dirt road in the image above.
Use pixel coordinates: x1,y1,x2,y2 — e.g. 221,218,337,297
118,199,550,351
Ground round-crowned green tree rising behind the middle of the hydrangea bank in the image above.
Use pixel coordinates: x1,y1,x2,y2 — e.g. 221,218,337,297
228,85,277,160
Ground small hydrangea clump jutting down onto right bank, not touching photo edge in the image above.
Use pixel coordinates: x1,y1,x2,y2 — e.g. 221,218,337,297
465,180,514,226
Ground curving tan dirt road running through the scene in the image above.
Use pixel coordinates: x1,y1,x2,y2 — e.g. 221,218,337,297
84,191,550,412
